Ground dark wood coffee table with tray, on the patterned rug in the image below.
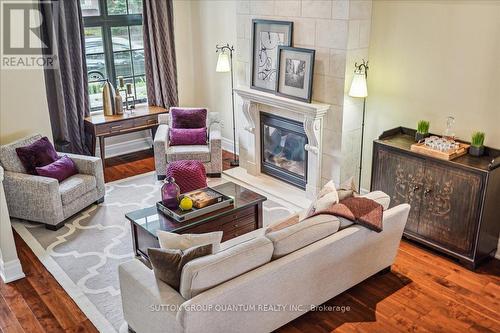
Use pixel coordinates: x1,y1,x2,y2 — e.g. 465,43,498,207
125,182,267,259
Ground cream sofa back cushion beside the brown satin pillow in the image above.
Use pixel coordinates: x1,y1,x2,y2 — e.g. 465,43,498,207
179,237,273,299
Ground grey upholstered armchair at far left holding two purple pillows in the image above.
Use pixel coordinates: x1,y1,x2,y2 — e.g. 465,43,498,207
0,134,105,230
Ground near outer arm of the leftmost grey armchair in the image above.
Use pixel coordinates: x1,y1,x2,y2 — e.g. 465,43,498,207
3,171,64,224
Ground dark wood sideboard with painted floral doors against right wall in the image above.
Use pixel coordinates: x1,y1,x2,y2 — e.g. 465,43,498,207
371,127,500,269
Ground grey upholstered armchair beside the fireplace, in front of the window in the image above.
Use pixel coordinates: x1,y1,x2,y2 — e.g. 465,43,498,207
153,108,222,180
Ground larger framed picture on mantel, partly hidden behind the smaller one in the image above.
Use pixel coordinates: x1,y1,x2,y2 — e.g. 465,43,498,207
250,19,293,92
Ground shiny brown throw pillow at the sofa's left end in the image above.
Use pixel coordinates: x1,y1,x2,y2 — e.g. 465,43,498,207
148,244,212,290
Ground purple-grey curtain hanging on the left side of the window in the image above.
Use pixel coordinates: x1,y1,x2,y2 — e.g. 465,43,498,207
40,0,90,155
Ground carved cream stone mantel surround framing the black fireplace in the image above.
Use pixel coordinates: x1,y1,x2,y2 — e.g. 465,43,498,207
234,88,330,199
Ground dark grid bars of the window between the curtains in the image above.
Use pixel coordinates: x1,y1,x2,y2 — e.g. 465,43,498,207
83,0,147,114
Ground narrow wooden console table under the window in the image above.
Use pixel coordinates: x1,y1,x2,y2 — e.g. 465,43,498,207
85,105,168,168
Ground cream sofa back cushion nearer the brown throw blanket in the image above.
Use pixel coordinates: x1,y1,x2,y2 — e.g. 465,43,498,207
266,214,340,259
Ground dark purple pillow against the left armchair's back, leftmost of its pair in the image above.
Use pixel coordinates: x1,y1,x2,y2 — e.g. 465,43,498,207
16,136,59,175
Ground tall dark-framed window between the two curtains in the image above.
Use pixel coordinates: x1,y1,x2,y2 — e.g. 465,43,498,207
81,0,147,111
